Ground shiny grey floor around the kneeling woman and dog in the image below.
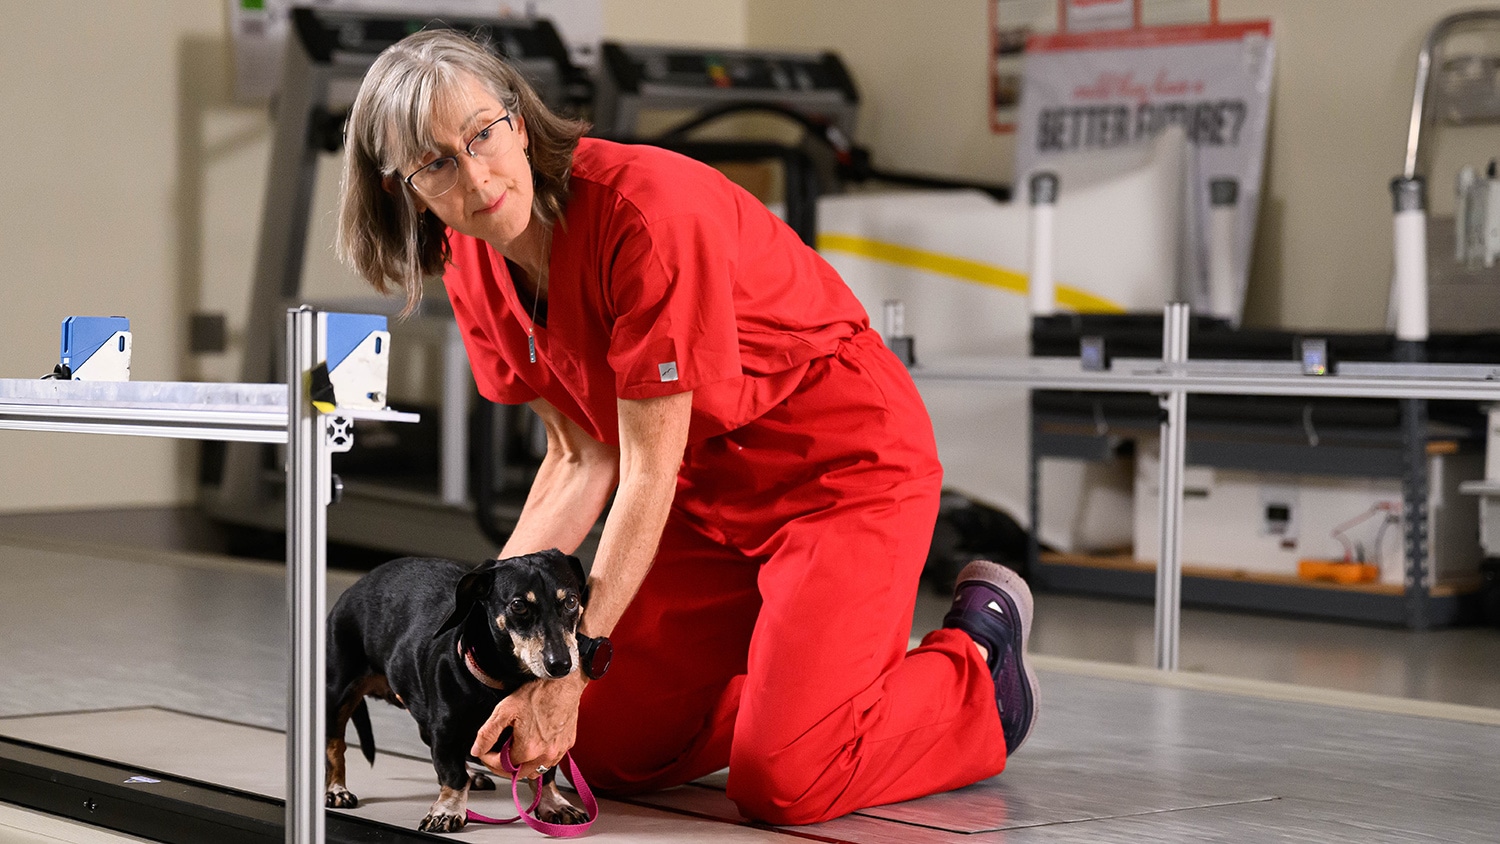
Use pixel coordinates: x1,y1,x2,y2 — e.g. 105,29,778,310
0,531,1500,844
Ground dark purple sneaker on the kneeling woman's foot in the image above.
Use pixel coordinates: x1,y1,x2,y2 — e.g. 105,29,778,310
942,559,1037,756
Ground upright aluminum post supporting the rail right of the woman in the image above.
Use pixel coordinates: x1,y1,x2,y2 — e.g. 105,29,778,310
1157,303,1191,672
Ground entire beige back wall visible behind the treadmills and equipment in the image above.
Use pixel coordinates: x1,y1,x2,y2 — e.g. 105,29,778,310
0,0,1494,511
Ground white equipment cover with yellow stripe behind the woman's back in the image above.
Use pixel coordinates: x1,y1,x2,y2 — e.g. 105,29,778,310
818,132,1187,550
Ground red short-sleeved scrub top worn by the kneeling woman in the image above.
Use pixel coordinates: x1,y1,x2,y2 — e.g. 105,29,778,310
443,138,870,444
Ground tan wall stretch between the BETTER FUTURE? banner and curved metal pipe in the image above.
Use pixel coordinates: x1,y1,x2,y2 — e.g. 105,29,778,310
1220,0,1482,330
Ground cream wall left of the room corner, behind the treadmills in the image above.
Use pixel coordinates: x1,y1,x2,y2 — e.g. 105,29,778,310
0,0,746,513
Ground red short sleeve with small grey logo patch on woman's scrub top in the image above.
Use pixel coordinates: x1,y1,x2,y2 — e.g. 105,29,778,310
608,211,743,399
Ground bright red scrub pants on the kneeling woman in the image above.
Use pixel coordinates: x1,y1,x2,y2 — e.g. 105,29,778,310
573,331,1005,823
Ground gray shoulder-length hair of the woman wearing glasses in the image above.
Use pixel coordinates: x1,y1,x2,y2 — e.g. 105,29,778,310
336,30,588,315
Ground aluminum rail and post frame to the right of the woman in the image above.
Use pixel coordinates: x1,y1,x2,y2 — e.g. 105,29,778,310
912,304,1500,670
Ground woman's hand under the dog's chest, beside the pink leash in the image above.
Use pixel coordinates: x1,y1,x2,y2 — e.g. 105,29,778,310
471,672,588,780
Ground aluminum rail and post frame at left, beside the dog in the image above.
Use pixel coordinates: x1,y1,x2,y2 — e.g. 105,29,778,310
0,307,417,844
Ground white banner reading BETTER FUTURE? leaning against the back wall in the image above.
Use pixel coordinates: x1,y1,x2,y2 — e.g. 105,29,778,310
1016,21,1275,324
